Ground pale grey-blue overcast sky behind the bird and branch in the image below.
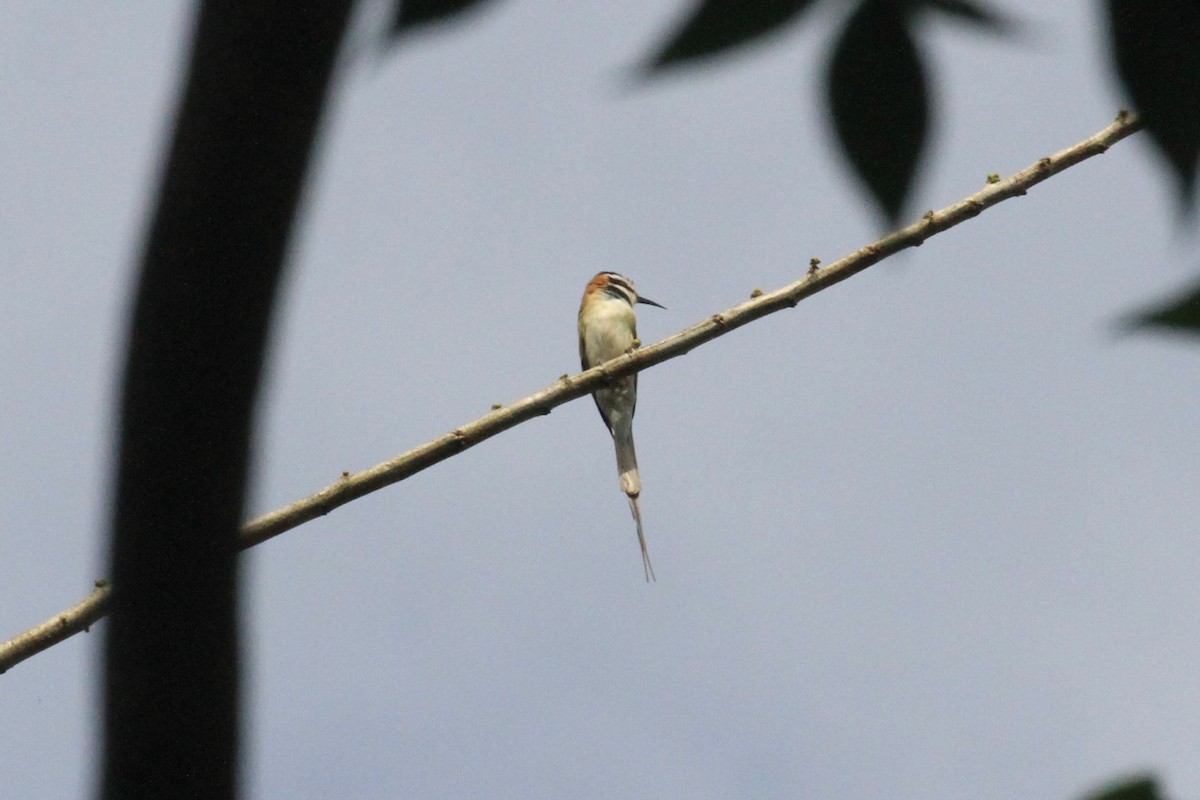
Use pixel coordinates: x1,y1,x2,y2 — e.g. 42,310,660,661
0,0,1200,800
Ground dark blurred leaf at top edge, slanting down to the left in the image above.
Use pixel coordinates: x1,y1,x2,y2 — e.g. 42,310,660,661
644,0,812,72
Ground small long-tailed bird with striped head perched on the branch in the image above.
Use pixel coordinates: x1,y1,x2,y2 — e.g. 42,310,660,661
580,272,666,583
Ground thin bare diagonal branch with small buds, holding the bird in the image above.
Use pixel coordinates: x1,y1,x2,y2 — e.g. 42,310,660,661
0,112,1141,673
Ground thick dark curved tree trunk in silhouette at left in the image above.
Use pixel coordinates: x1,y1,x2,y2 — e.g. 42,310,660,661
101,0,352,800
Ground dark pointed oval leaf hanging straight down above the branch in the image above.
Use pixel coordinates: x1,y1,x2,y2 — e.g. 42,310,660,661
827,0,930,224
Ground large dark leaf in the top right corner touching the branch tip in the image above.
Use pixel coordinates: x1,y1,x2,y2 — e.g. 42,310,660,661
1108,0,1200,209
